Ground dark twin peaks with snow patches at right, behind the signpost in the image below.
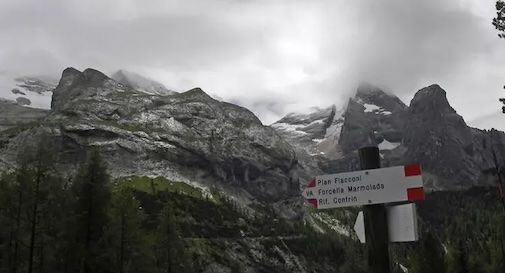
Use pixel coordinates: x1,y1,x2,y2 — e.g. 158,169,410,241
272,84,505,189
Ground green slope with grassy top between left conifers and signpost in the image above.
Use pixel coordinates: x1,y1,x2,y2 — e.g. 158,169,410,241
113,177,362,272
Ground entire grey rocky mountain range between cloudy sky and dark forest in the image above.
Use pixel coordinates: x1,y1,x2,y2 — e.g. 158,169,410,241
0,68,505,200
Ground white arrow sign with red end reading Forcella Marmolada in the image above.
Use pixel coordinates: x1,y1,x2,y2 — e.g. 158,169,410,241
303,164,424,209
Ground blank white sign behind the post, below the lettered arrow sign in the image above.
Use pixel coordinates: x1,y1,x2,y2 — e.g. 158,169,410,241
354,203,419,243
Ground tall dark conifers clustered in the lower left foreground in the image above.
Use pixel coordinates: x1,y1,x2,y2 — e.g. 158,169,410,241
0,140,192,273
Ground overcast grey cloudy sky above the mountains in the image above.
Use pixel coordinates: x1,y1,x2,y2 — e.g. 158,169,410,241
0,0,505,129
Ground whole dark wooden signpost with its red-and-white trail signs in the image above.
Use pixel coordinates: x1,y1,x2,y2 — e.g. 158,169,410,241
303,147,425,273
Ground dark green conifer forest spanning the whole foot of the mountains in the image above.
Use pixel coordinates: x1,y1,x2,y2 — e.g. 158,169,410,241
0,136,505,273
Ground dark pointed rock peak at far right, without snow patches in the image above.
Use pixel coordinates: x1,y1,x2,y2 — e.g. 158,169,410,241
403,85,503,188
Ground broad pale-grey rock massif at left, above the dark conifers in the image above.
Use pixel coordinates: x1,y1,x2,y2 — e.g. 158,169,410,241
0,68,299,201
